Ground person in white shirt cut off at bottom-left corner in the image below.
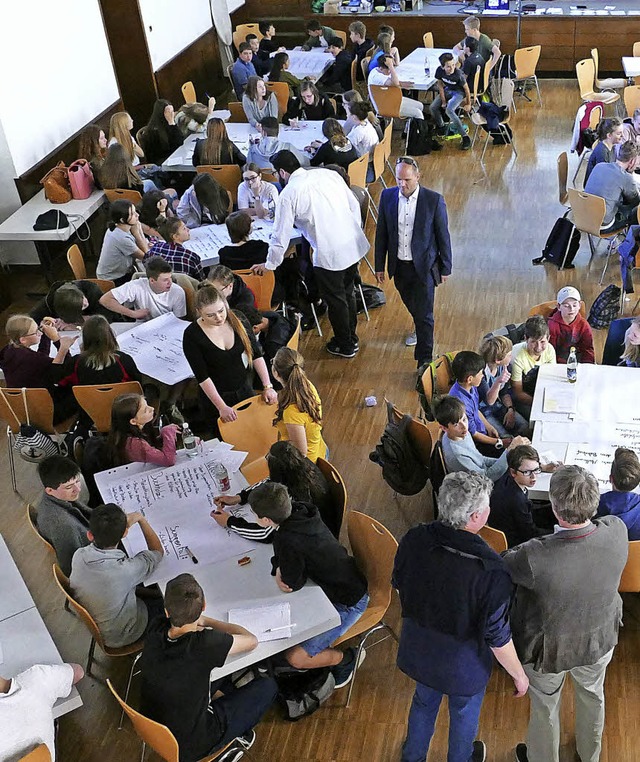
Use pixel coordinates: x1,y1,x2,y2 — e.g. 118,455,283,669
0,664,84,762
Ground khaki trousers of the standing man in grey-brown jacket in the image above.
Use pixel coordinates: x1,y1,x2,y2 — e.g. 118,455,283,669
524,649,613,762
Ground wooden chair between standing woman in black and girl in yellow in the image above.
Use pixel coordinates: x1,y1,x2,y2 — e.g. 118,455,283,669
218,394,278,463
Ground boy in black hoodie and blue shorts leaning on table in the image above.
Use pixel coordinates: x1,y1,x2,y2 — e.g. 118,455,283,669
249,482,369,688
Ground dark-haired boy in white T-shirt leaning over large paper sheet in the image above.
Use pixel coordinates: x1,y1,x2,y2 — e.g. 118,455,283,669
100,257,187,320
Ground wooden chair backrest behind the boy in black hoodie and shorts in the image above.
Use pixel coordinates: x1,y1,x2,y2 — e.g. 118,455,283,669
347,511,398,611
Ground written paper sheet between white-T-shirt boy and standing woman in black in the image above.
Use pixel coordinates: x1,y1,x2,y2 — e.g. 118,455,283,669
118,312,193,386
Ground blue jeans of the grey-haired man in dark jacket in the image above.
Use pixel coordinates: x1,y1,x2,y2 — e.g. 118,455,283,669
402,683,484,762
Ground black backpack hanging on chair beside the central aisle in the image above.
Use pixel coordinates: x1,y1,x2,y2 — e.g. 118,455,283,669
369,402,429,495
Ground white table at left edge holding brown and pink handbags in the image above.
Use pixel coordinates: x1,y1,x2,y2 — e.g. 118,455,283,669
0,190,105,280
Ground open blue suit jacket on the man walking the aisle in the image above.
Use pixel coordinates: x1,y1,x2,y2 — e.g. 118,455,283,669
375,187,451,285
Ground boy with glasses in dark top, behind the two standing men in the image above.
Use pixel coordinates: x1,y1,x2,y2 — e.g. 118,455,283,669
489,445,558,548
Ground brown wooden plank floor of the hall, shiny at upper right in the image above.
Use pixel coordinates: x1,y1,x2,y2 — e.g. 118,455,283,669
0,80,640,762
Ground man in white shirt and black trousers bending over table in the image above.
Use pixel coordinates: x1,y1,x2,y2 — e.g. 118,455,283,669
252,151,369,358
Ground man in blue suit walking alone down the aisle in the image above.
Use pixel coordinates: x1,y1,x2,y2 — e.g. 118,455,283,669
375,156,451,367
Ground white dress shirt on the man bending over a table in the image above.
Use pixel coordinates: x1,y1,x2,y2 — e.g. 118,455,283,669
266,167,369,271
